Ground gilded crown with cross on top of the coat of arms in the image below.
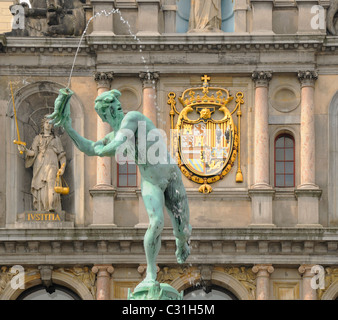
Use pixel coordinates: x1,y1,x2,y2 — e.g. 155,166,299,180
178,75,233,108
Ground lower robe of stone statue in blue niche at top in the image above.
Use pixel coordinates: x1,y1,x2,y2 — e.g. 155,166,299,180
188,0,222,32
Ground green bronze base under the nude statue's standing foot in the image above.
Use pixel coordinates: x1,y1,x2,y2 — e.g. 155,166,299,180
128,281,183,300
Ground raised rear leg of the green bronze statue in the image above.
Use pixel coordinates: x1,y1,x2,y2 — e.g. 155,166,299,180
164,172,191,263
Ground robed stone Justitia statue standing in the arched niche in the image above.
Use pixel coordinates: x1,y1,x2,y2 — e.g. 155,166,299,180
18,117,66,212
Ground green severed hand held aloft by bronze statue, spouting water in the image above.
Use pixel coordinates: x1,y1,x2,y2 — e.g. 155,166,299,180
47,88,74,127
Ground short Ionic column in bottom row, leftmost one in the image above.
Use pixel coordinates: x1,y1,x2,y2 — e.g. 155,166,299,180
92,264,114,300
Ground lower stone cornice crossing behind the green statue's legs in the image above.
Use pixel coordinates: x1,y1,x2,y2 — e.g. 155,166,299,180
0,228,338,265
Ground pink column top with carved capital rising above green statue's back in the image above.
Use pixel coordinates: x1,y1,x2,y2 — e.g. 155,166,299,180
139,72,159,126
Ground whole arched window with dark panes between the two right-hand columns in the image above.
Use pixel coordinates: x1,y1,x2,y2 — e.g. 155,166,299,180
275,134,295,187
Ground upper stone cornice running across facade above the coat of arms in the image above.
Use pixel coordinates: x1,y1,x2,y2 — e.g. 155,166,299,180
5,33,338,53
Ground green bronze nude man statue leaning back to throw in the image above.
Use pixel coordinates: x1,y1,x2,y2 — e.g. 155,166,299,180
49,89,191,299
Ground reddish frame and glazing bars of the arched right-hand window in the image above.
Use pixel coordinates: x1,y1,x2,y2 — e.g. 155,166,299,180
273,132,296,188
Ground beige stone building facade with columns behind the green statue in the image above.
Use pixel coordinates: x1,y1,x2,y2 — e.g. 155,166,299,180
0,0,338,300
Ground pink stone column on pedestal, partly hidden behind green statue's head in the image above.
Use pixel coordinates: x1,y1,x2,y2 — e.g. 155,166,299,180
90,72,116,227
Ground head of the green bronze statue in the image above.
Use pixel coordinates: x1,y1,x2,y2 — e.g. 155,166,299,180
95,89,124,125
